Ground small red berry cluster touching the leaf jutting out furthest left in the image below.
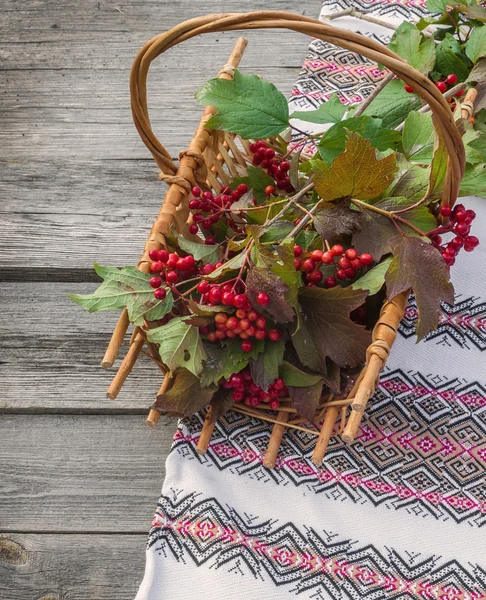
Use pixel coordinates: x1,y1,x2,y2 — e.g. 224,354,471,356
149,250,197,300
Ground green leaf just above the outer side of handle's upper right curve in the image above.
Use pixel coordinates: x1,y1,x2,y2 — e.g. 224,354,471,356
388,21,435,74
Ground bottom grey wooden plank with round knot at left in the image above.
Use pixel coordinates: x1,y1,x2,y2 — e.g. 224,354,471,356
0,536,146,600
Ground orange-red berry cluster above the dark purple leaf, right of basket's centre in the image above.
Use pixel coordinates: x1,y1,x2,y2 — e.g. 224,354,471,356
294,244,373,288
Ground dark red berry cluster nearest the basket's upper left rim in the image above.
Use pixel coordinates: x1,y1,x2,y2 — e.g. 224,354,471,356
189,183,248,240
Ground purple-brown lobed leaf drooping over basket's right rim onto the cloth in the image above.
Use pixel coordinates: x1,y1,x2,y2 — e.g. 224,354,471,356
385,236,454,340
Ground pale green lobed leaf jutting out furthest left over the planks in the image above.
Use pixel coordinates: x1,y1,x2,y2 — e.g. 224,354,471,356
68,265,174,326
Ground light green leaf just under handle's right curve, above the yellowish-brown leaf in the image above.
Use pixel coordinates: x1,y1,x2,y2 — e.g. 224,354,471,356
364,79,420,129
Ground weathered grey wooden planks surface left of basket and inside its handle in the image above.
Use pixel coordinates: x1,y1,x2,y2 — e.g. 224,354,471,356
0,0,312,600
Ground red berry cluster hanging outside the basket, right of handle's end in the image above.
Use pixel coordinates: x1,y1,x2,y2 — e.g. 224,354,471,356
428,204,479,266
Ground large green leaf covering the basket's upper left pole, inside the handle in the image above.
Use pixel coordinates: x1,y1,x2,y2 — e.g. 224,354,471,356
196,70,289,140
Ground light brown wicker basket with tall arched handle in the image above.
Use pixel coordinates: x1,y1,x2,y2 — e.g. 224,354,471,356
102,11,468,467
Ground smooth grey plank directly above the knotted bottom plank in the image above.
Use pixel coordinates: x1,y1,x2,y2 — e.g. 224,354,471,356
0,415,175,534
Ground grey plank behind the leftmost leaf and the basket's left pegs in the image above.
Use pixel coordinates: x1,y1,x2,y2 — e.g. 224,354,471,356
0,283,170,415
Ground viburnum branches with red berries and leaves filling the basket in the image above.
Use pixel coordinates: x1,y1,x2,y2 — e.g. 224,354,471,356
71,15,486,435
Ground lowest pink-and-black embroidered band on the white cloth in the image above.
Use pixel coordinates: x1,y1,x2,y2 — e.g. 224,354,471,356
148,490,486,600
